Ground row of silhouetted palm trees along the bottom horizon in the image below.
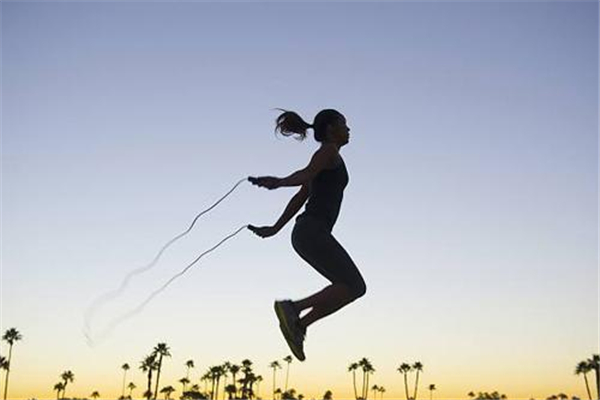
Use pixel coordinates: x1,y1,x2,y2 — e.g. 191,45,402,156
0,328,600,400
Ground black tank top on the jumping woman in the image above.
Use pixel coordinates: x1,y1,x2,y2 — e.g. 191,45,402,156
305,157,348,230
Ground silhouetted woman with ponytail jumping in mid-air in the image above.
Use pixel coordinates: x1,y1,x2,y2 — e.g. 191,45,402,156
248,110,366,361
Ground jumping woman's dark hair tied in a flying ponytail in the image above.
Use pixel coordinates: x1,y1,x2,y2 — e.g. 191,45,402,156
275,108,344,142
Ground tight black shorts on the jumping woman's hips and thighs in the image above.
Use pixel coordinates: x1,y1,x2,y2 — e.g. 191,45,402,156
292,214,366,297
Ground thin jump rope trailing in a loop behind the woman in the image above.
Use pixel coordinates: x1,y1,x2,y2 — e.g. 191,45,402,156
83,177,259,346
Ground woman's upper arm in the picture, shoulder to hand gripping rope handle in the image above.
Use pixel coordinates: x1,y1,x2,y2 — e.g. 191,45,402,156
248,145,338,189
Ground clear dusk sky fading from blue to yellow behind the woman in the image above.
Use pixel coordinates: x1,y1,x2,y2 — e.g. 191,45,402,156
0,1,599,399
